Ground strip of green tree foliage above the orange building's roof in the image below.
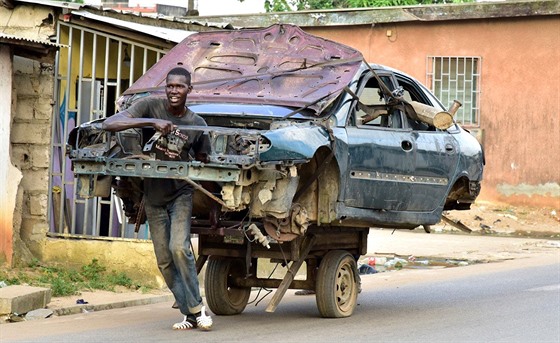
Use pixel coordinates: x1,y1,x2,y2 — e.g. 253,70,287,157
239,0,474,12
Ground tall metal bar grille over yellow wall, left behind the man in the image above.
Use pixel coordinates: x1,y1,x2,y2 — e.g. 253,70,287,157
48,22,167,239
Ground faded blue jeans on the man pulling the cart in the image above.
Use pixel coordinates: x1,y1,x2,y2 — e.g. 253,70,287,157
145,194,202,315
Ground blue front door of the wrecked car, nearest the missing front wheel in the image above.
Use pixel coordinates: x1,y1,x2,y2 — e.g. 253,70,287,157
344,72,415,211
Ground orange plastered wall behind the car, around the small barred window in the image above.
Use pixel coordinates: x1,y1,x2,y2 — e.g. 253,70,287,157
305,16,560,208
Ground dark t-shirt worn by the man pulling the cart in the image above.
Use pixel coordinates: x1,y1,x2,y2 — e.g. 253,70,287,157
127,97,210,206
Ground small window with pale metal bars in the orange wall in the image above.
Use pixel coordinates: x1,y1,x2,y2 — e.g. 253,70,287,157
426,56,481,127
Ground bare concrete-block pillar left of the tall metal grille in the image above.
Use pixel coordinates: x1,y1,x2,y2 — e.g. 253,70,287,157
11,56,54,266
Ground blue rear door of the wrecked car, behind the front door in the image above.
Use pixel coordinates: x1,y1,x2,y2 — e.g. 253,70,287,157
395,73,460,211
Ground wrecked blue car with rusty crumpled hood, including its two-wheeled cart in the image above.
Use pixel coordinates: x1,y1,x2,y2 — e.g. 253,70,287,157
68,24,484,317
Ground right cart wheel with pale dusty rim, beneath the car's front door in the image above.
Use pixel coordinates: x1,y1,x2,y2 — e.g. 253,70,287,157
315,250,358,318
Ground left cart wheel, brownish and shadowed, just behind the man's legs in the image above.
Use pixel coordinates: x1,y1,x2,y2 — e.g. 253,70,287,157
204,256,251,315
